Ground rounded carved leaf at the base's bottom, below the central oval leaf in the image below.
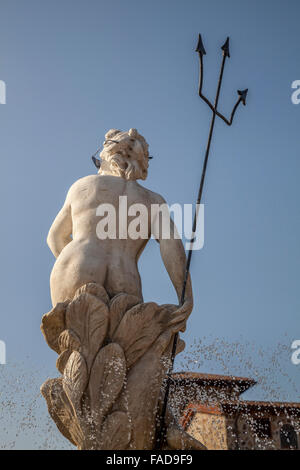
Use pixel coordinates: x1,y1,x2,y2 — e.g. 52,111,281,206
100,411,131,450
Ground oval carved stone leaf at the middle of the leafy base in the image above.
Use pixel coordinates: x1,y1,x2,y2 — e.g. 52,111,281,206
89,343,126,418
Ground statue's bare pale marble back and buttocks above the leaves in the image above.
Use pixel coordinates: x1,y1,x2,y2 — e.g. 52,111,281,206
50,175,155,305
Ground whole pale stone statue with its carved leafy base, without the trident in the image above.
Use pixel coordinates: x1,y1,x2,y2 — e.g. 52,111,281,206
41,129,204,450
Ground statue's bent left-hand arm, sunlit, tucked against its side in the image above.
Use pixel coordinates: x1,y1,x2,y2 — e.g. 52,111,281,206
47,197,72,258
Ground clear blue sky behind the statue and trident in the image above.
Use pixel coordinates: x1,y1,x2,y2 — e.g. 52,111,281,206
0,0,300,447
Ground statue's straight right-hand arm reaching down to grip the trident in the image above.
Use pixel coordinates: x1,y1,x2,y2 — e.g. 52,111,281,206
155,196,193,315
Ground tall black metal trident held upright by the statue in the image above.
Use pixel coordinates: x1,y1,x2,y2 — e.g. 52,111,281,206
158,34,248,449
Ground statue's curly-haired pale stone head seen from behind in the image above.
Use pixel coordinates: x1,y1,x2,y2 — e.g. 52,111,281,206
99,129,149,180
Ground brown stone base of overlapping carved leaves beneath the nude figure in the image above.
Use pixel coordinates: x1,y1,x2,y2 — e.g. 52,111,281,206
41,283,203,450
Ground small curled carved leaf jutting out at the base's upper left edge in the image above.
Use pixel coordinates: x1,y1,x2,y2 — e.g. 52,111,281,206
41,301,69,354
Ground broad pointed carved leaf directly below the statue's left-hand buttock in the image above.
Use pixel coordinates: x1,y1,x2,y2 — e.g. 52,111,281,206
66,292,108,368
